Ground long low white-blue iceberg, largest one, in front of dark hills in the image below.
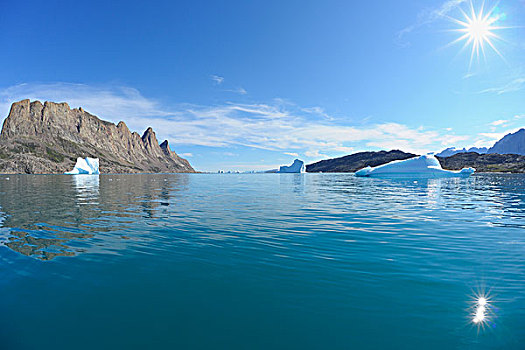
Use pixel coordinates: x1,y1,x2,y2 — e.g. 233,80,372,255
355,154,476,178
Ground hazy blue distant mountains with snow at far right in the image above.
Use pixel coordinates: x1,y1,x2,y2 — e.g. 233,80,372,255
436,129,525,157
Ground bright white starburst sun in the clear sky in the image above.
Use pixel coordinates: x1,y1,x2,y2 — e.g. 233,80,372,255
450,1,506,66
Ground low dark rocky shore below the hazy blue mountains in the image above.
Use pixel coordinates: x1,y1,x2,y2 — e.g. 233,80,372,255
437,152,525,173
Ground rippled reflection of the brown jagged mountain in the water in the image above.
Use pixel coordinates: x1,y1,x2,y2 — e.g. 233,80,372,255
0,175,188,260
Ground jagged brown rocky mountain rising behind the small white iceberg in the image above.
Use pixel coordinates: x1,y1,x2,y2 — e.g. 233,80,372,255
0,100,195,174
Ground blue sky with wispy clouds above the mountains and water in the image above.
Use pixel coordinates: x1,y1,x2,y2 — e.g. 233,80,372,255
0,0,525,171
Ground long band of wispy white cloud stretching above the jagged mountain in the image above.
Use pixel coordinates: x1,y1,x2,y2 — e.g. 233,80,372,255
0,83,466,158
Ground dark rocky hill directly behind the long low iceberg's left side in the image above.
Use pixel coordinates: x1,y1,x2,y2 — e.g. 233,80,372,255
306,150,416,173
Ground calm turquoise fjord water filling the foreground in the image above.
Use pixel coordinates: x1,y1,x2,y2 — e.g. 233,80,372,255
0,174,525,349
